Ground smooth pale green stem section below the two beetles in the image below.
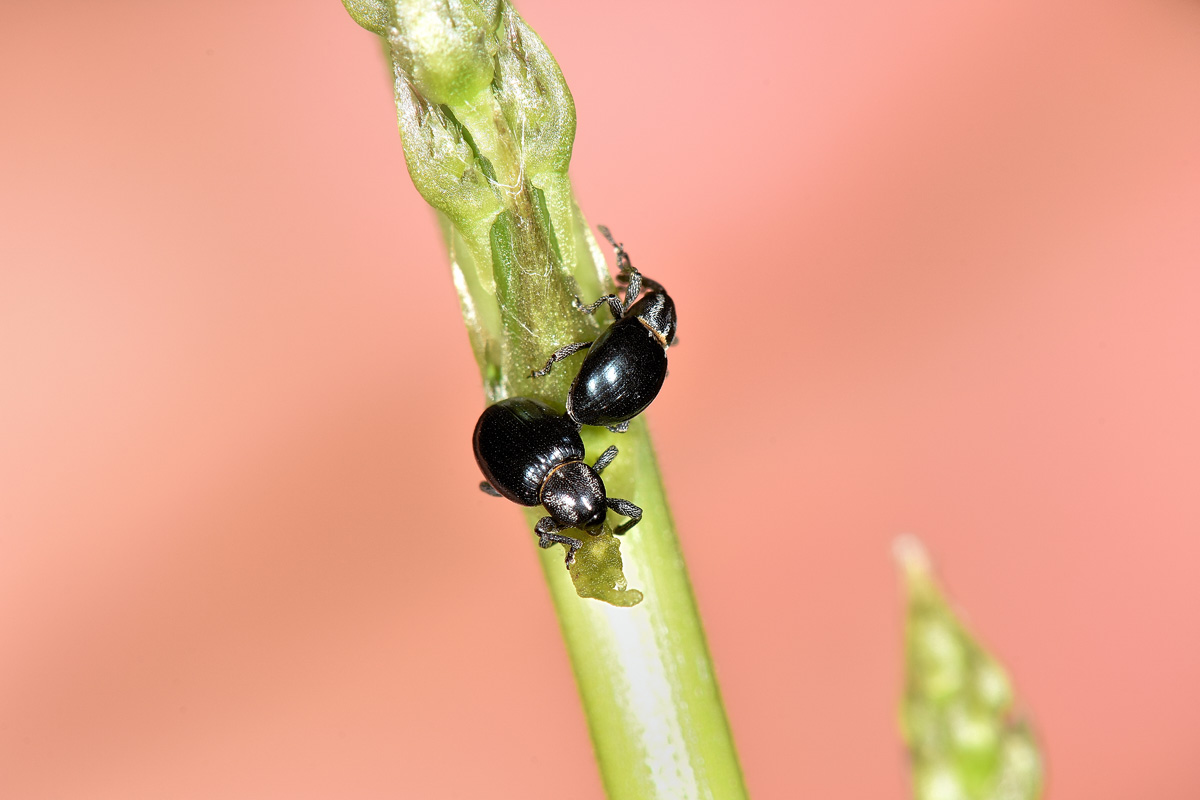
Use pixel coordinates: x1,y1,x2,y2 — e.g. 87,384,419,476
542,421,746,800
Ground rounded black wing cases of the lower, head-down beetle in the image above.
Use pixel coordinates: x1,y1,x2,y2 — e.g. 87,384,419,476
472,397,583,506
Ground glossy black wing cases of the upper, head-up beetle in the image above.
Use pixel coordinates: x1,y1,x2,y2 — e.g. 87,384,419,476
566,317,667,425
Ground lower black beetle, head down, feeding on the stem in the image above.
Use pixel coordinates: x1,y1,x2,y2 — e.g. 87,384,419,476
473,397,642,566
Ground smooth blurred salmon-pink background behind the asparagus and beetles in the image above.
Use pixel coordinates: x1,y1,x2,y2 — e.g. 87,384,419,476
0,0,1200,800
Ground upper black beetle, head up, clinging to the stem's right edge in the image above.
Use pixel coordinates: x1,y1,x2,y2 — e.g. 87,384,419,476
532,225,678,433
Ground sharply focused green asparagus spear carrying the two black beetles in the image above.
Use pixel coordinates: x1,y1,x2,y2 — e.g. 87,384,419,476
343,0,745,800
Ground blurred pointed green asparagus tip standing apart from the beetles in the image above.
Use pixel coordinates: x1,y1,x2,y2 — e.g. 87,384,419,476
896,537,1043,800
